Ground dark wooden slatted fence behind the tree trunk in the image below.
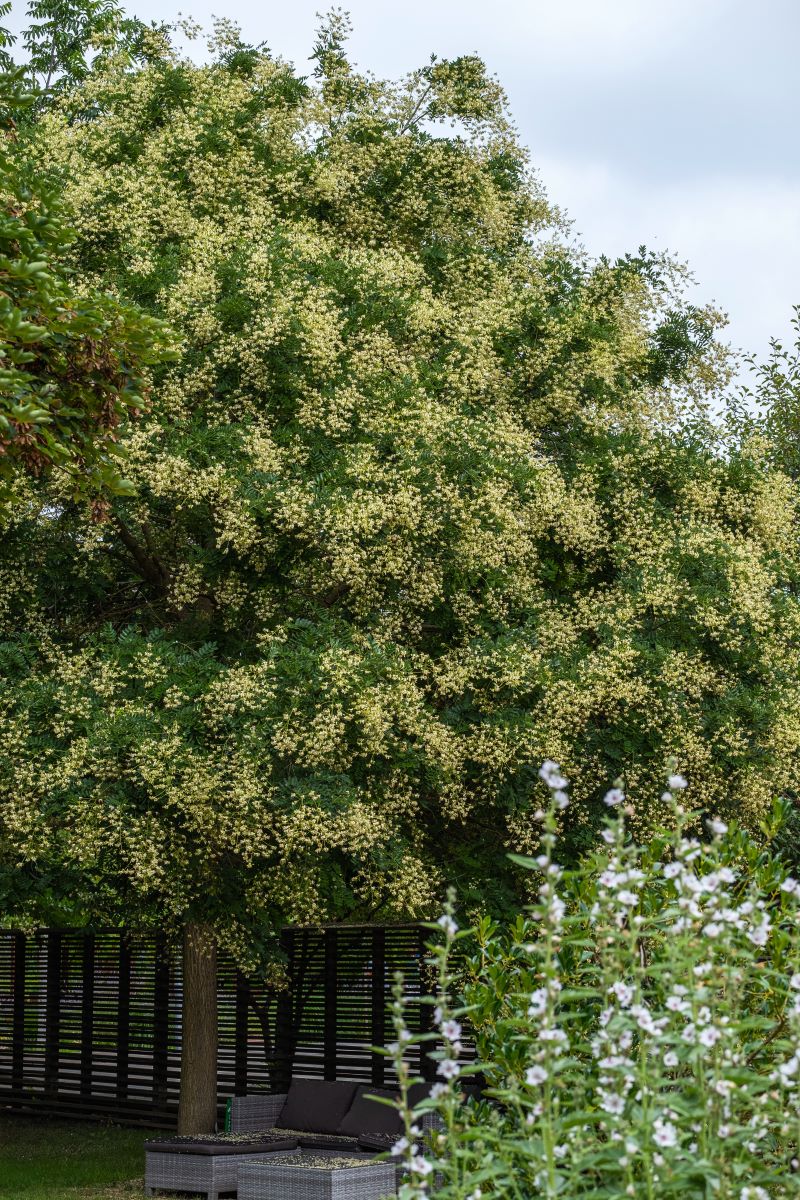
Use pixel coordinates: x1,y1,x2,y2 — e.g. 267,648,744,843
0,925,432,1128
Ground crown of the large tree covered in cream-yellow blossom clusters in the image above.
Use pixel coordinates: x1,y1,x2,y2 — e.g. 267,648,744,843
0,18,800,1128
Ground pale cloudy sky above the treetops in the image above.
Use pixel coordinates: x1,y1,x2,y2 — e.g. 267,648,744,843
17,0,800,379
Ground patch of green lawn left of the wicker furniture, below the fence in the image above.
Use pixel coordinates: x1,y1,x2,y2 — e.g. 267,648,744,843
0,1116,160,1200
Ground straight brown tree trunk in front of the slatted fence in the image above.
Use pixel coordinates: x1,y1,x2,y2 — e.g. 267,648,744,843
178,922,217,1134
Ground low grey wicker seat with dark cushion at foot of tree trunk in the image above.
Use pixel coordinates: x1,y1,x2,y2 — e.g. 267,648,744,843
144,1134,297,1200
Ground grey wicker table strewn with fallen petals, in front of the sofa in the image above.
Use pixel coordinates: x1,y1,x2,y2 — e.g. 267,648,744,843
237,1153,397,1200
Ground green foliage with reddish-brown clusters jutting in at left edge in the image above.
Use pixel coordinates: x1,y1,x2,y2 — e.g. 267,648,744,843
0,68,173,514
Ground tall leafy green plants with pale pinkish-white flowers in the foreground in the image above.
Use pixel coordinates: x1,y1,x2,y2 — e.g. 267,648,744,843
392,762,800,1200
